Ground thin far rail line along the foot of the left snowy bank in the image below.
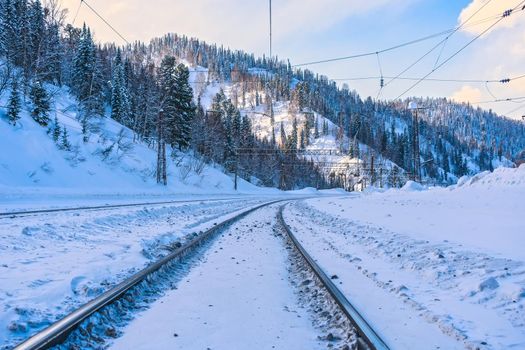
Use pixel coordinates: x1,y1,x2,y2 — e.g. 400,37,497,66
0,197,248,218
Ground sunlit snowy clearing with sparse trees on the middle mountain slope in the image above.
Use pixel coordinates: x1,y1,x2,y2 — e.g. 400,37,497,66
202,80,407,190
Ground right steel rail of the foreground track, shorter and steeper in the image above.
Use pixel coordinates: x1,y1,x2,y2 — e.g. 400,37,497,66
278,205,390,350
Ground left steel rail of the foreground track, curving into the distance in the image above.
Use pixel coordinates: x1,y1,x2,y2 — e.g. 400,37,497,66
14,199,286,350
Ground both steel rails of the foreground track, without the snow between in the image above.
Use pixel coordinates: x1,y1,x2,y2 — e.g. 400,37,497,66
14,199,389,350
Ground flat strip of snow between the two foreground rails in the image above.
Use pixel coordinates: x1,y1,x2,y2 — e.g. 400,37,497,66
111,206,327,350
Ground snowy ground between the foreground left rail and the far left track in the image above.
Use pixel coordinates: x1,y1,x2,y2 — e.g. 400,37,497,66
0,197,274,348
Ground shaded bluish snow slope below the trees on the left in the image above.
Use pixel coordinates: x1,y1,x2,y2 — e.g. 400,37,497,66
0,85,270,194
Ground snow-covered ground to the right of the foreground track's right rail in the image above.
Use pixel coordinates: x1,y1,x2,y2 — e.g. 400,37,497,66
285,166,525,349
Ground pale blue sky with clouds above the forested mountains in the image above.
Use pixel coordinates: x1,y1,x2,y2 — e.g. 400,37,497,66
61,0,525,119
